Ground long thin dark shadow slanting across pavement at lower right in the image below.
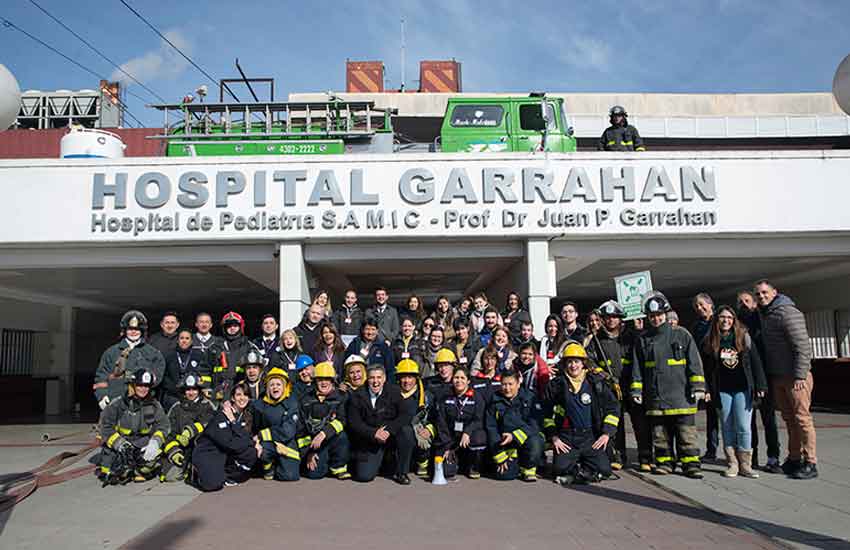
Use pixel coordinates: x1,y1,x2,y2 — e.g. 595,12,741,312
572,485,850,550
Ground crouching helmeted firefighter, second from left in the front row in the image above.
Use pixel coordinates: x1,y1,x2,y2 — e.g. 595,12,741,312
159,371,215,481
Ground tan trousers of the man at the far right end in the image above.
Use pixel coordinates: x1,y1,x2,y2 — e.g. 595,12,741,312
773,372,818,464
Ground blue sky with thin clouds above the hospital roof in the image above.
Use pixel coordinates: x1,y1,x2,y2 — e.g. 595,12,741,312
0,0,850,125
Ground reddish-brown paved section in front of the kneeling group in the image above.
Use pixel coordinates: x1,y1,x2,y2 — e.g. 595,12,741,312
117,476,777,550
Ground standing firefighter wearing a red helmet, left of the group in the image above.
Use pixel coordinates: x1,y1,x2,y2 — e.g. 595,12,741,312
207,311,257,403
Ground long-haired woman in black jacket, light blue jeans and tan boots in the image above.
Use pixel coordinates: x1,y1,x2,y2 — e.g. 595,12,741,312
700,306,767,478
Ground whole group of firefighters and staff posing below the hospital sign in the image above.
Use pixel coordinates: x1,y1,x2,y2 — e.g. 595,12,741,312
93,281,817,491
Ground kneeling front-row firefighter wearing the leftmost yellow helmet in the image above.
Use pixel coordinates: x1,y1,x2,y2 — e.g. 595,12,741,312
251,368,301,481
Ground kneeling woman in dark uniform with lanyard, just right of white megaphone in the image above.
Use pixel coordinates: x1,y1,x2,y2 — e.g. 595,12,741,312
435,367,487,479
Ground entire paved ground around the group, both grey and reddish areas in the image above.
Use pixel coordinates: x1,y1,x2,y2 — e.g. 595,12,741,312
0,414,850,550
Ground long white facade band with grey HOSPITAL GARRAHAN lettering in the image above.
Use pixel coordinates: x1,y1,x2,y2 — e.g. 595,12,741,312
0,153,850,242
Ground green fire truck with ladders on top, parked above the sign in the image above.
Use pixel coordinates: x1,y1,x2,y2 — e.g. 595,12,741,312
152,93,576,157
